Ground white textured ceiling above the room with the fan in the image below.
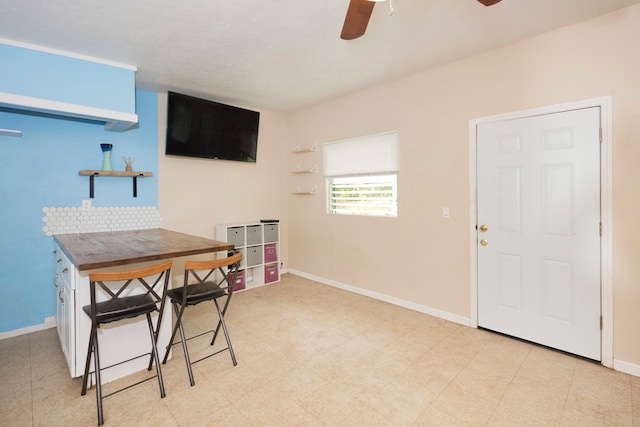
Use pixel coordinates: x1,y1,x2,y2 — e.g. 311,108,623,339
0,0,640,112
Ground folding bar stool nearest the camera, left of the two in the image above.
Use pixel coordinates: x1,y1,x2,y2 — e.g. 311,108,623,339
81,261,172,426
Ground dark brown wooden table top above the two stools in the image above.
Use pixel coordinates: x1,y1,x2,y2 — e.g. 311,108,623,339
53,228,233,271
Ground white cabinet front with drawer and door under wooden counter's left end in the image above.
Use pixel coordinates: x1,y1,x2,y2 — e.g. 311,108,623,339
53,247,76,376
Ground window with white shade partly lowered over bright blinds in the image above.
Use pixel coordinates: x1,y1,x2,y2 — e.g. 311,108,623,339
322,132,398,217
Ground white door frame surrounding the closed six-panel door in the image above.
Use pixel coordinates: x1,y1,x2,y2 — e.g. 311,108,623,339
469,96,613,368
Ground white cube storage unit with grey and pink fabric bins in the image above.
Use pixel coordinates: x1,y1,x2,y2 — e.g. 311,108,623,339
216,221,280,290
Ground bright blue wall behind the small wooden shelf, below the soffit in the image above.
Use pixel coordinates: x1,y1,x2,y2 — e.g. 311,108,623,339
0,91,158,332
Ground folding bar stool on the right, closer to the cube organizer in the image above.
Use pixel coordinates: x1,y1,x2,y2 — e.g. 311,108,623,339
162,252,242,386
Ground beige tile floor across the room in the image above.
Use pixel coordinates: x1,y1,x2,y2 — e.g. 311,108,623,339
0,275,640,427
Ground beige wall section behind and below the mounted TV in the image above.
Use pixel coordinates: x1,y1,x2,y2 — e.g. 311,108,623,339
158,93,289,277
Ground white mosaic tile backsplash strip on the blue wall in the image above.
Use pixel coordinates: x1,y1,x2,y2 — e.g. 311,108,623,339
42,206,162,236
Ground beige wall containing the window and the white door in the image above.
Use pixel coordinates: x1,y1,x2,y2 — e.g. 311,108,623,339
288,6,640,372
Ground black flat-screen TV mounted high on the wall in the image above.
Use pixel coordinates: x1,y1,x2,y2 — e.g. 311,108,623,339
165,92,260,163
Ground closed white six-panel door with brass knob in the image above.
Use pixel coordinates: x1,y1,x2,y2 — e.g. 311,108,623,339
477,107,601,360
